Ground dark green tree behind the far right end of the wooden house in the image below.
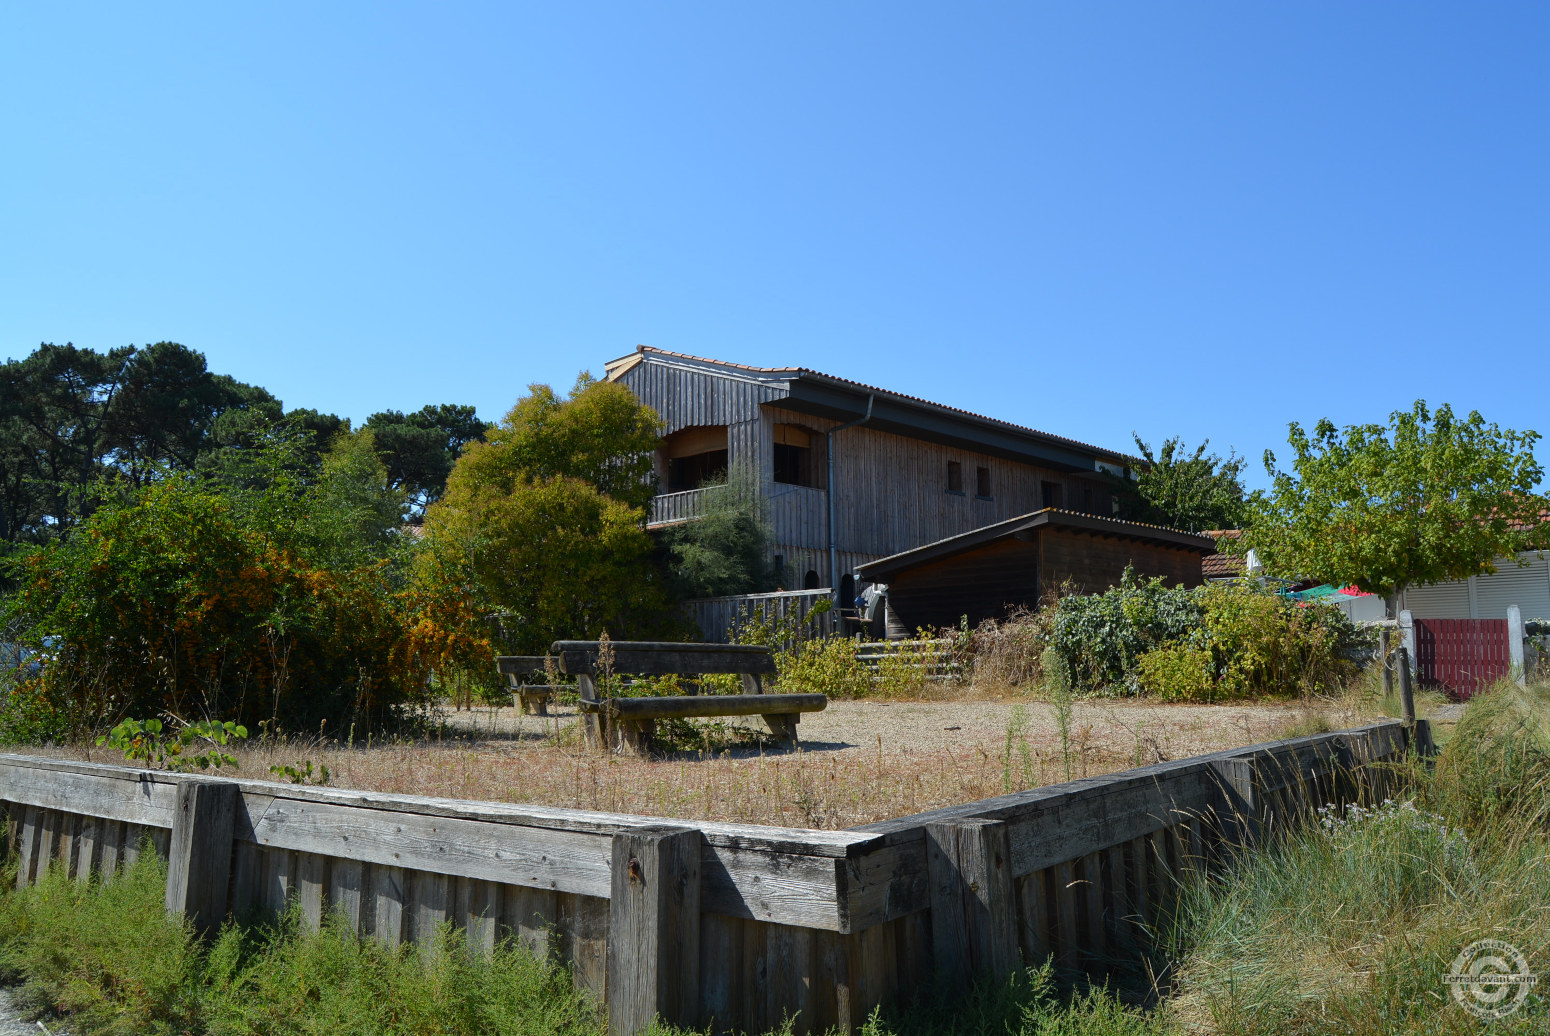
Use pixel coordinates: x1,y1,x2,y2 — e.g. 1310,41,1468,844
1113,433,1246,532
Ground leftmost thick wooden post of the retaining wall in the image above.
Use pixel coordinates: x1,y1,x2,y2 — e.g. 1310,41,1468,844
166,777,237,935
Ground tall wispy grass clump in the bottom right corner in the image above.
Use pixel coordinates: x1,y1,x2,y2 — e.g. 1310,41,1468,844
1169,687,1550,1036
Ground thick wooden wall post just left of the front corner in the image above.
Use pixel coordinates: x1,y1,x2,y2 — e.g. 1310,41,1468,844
608,827,704,1036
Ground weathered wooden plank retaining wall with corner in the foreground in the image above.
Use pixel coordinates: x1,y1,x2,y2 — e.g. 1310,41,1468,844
0,721,1428,1033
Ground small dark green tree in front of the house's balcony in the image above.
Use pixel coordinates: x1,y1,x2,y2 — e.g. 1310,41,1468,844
657,467,770,597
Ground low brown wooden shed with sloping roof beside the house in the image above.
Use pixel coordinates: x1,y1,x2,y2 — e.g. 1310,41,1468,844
859,509,1215,637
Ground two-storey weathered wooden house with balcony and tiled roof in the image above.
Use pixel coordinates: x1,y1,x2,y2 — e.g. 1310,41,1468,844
606,346,1140,603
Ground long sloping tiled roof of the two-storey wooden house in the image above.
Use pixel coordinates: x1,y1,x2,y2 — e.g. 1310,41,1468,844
605,346,1141,471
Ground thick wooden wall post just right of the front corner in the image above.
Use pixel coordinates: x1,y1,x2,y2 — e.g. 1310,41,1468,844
925,819,1018,986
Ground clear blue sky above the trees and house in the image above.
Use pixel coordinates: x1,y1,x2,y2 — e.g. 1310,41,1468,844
0,0,1550,484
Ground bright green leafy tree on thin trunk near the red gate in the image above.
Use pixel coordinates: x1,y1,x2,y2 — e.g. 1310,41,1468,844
1237,400,1550,599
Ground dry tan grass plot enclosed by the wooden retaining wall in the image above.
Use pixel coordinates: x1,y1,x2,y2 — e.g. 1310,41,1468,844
21,699,1382,830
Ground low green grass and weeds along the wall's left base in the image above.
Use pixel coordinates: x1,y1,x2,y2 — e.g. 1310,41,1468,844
0,851,606,1036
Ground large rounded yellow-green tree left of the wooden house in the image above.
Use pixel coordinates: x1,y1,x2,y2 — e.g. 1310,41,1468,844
415,375,676,653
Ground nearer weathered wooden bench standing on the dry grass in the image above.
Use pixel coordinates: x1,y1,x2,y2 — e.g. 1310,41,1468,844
550,641,829,755
